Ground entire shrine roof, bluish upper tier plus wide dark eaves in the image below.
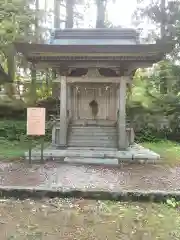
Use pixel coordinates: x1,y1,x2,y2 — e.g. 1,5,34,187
15,28,173,64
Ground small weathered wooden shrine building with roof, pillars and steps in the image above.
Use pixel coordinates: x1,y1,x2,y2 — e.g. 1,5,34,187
15,28,172,159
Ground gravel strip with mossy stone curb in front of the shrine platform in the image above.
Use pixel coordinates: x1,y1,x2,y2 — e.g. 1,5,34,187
0,162,180,201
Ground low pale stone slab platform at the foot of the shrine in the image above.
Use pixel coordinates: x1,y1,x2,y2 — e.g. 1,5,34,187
25,144,160,165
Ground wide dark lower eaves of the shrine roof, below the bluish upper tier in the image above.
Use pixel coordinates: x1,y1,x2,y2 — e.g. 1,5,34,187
15,40,172,60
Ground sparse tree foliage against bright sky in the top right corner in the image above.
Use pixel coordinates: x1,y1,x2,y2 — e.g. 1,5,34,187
134,0,180,51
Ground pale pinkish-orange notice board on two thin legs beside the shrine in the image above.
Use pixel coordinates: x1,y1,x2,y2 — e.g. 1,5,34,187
27,108,46,164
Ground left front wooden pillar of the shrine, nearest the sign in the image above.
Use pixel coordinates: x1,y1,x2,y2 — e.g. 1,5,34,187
59,76,67,147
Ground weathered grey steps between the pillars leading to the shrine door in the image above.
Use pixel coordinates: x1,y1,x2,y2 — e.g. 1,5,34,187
68,124,118,148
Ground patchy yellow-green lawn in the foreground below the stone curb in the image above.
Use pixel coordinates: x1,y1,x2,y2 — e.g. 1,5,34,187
0,199,180,240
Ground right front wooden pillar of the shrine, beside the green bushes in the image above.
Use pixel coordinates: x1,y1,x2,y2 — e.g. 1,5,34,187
118,77,127,150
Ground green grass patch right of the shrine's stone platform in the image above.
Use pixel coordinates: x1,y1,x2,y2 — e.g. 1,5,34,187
142,141,180,164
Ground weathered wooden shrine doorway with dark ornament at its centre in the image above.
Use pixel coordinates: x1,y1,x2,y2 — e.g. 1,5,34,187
72,83,117,120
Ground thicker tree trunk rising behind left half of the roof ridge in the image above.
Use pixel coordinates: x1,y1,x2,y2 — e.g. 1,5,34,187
65,0,75,28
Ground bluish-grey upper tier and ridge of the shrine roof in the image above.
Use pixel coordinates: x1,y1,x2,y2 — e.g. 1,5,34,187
49,28,139,46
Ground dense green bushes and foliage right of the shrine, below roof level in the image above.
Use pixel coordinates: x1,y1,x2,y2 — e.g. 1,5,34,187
127,61,180,142
